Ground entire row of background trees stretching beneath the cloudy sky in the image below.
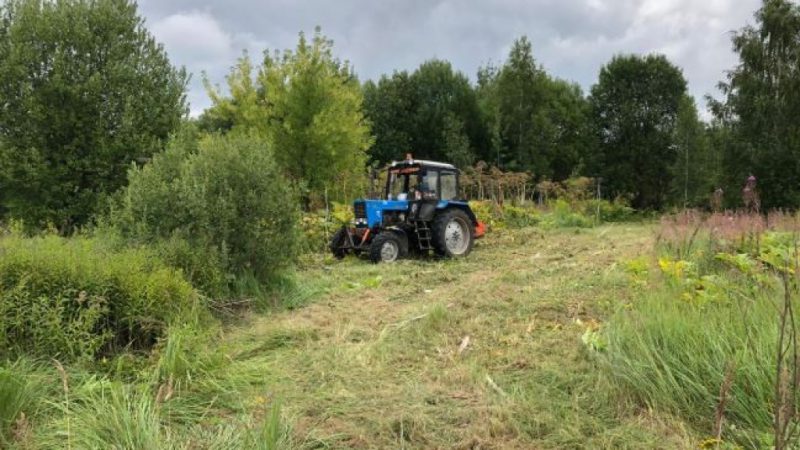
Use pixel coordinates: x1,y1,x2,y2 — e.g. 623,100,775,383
0,0,800,232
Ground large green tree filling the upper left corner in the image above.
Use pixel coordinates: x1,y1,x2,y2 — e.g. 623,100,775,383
0,0,186,233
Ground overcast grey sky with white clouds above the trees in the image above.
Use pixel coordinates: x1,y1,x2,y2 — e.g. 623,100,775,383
139,0,761,116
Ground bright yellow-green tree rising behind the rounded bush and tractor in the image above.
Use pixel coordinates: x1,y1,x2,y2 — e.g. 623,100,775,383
201,29,372,204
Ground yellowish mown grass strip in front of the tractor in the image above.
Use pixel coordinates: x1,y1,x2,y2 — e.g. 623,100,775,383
212,224,699,449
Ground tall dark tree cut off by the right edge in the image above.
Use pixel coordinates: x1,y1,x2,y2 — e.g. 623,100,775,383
712,0,800,208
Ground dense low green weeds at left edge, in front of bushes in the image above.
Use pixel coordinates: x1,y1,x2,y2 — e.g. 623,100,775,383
0,234,198,361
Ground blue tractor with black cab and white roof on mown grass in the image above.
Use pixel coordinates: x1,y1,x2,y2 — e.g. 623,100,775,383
330,155,486,263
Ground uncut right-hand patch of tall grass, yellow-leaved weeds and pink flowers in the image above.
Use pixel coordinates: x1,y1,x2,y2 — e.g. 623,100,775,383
600,213,800,448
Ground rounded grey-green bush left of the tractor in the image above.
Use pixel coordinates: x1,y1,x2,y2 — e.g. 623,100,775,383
109,128,298,295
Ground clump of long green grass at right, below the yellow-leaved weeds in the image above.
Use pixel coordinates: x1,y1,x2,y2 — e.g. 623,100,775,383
603,289,777,440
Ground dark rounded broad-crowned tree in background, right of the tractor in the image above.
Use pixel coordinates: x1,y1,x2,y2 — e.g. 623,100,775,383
588,55,687,209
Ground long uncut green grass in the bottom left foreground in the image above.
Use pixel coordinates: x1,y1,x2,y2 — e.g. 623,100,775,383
26,326,292,450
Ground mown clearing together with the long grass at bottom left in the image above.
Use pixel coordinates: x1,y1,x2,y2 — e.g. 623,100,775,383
0,224,702,449
